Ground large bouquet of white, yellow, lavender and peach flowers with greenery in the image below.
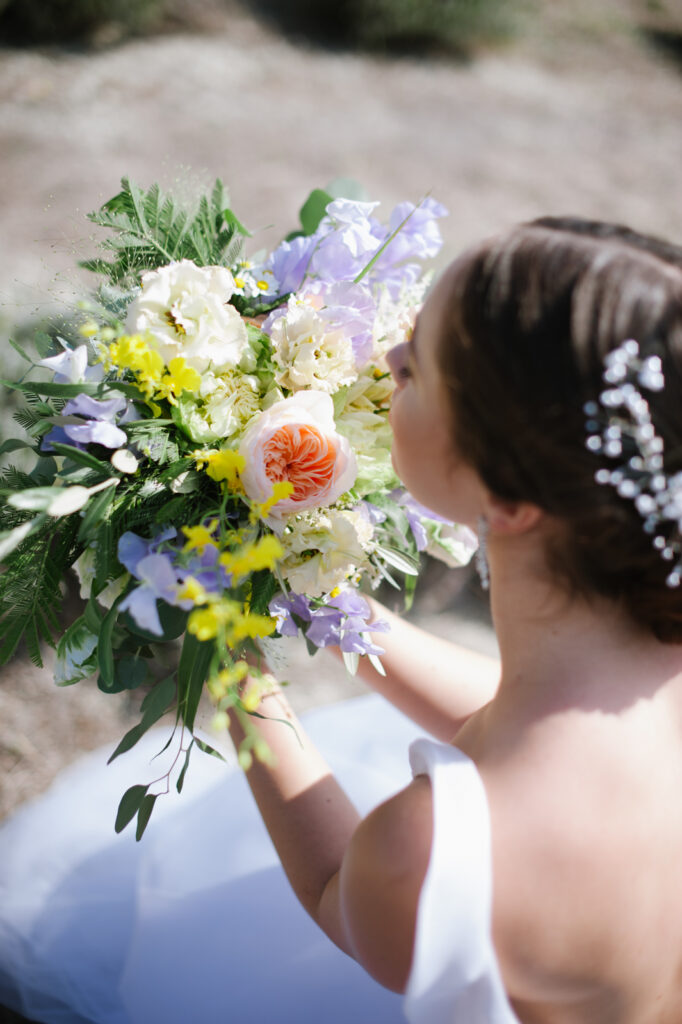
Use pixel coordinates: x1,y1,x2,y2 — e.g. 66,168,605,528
0,179,474,838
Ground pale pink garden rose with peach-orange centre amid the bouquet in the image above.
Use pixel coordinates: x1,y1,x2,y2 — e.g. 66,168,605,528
240,391,357,517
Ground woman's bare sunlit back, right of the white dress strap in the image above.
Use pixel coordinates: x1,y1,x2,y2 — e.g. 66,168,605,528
458,694,682,1024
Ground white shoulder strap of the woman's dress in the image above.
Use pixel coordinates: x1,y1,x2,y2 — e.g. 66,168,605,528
404,739,518,1024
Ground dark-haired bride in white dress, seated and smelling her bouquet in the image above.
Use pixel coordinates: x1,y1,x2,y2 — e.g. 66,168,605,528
0,211,682,1024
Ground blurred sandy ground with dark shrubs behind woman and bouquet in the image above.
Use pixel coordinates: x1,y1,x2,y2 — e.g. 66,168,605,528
0,0,682,817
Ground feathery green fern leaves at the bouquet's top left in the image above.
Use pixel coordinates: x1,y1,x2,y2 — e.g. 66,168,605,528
81,178,248,291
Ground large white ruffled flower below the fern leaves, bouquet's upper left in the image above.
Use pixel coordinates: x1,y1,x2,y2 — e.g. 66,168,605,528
126,259,248,374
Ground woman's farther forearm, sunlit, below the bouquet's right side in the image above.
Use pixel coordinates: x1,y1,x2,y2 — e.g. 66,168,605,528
337,598,500,742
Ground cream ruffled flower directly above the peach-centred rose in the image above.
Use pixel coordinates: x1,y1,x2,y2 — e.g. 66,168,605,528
270,297,357,394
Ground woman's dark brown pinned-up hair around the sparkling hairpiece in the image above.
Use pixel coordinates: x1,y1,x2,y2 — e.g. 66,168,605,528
439,218,682,643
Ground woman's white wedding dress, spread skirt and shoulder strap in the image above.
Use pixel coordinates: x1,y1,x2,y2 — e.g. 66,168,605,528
0,695,516,1024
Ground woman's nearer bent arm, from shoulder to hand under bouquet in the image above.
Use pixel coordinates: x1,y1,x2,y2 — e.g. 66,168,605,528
229,680,431,991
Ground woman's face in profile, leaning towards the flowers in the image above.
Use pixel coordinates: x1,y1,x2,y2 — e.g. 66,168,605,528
388,267,483,525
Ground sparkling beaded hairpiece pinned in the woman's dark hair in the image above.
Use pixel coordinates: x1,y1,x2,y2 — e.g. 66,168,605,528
584,338,682,587
